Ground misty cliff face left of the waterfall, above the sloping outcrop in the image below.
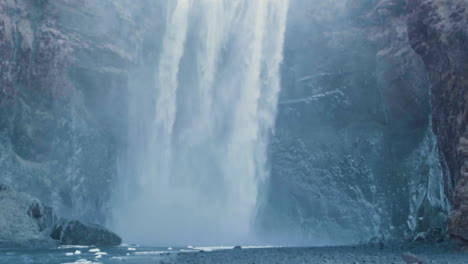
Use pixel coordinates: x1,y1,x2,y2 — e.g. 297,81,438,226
0,0,138,222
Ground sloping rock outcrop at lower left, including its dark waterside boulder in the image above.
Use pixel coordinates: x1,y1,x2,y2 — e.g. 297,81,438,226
0,184,122,248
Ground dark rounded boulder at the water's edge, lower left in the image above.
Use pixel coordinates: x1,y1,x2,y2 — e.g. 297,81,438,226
50,220,122,246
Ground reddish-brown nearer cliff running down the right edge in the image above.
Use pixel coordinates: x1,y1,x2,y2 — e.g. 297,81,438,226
408,0,468,242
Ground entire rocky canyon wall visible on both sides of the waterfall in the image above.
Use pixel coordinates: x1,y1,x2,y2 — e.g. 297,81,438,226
0,0,468,244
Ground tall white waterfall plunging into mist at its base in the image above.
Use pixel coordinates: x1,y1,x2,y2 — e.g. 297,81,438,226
114,0,288,245
